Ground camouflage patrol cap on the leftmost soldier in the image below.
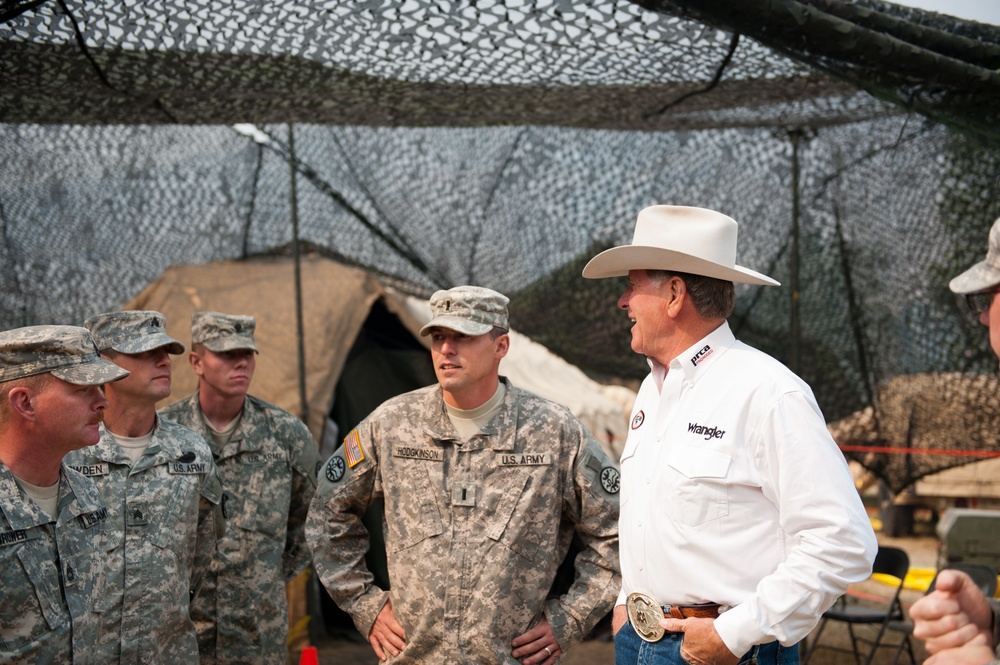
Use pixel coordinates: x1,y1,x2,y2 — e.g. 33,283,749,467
0,326,129,386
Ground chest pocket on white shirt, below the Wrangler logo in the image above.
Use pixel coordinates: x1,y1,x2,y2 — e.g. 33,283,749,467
659,446,732,526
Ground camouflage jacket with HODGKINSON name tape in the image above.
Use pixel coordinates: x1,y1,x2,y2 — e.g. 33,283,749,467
307,379,621,663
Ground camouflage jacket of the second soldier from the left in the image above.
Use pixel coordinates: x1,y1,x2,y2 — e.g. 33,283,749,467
65,417,223,663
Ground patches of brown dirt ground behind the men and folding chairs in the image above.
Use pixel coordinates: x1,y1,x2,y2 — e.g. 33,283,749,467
288,534,938,665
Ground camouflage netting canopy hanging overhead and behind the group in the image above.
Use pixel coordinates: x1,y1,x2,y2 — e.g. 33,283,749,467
0,0,1000,490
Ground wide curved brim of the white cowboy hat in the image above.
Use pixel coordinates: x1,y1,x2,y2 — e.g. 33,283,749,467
583,245,781,286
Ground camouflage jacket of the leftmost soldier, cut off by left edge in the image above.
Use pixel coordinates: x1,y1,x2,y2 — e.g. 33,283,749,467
0,462,108,665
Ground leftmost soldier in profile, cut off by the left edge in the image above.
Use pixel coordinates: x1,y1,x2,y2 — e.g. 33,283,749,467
0,326,128,665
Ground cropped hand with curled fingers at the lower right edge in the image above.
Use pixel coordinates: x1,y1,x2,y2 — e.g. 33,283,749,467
910,569,993,662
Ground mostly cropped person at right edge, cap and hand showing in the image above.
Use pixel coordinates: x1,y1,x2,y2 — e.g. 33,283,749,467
910,214,1000,665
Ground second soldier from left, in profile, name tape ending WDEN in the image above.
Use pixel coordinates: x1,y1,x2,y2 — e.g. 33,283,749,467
66,311,223,663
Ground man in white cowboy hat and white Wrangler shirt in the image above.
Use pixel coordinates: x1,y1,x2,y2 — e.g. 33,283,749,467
583,206,877,665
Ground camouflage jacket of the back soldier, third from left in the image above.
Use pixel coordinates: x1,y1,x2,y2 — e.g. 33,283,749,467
160,392,319,665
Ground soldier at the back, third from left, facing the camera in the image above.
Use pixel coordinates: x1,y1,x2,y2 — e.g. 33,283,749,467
161,312,319,665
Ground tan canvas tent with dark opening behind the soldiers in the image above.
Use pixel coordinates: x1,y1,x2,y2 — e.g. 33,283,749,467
125,254,633,458
